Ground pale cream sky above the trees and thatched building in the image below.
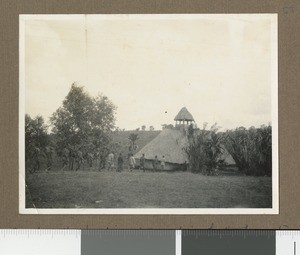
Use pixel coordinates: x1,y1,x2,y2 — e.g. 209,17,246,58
21,15,277,130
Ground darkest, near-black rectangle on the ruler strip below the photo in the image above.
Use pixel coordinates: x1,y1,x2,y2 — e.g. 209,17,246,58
182,230,276,255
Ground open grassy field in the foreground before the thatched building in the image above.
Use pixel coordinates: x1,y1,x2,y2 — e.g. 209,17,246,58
26,170,272,208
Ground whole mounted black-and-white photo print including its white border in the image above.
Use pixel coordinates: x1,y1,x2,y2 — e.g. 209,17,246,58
19,14,279,214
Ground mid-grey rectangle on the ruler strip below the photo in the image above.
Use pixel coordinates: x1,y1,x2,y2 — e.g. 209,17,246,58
81,230,175,255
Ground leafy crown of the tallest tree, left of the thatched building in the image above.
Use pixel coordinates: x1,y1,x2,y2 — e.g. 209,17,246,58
50,83,116,150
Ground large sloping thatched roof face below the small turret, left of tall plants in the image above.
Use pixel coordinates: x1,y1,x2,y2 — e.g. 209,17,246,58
134,129,188,164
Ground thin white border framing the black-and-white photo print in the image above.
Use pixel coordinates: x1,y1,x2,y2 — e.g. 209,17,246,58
19,13,279,215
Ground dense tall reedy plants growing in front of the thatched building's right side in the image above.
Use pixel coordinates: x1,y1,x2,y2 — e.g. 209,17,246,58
186,125,272,176
